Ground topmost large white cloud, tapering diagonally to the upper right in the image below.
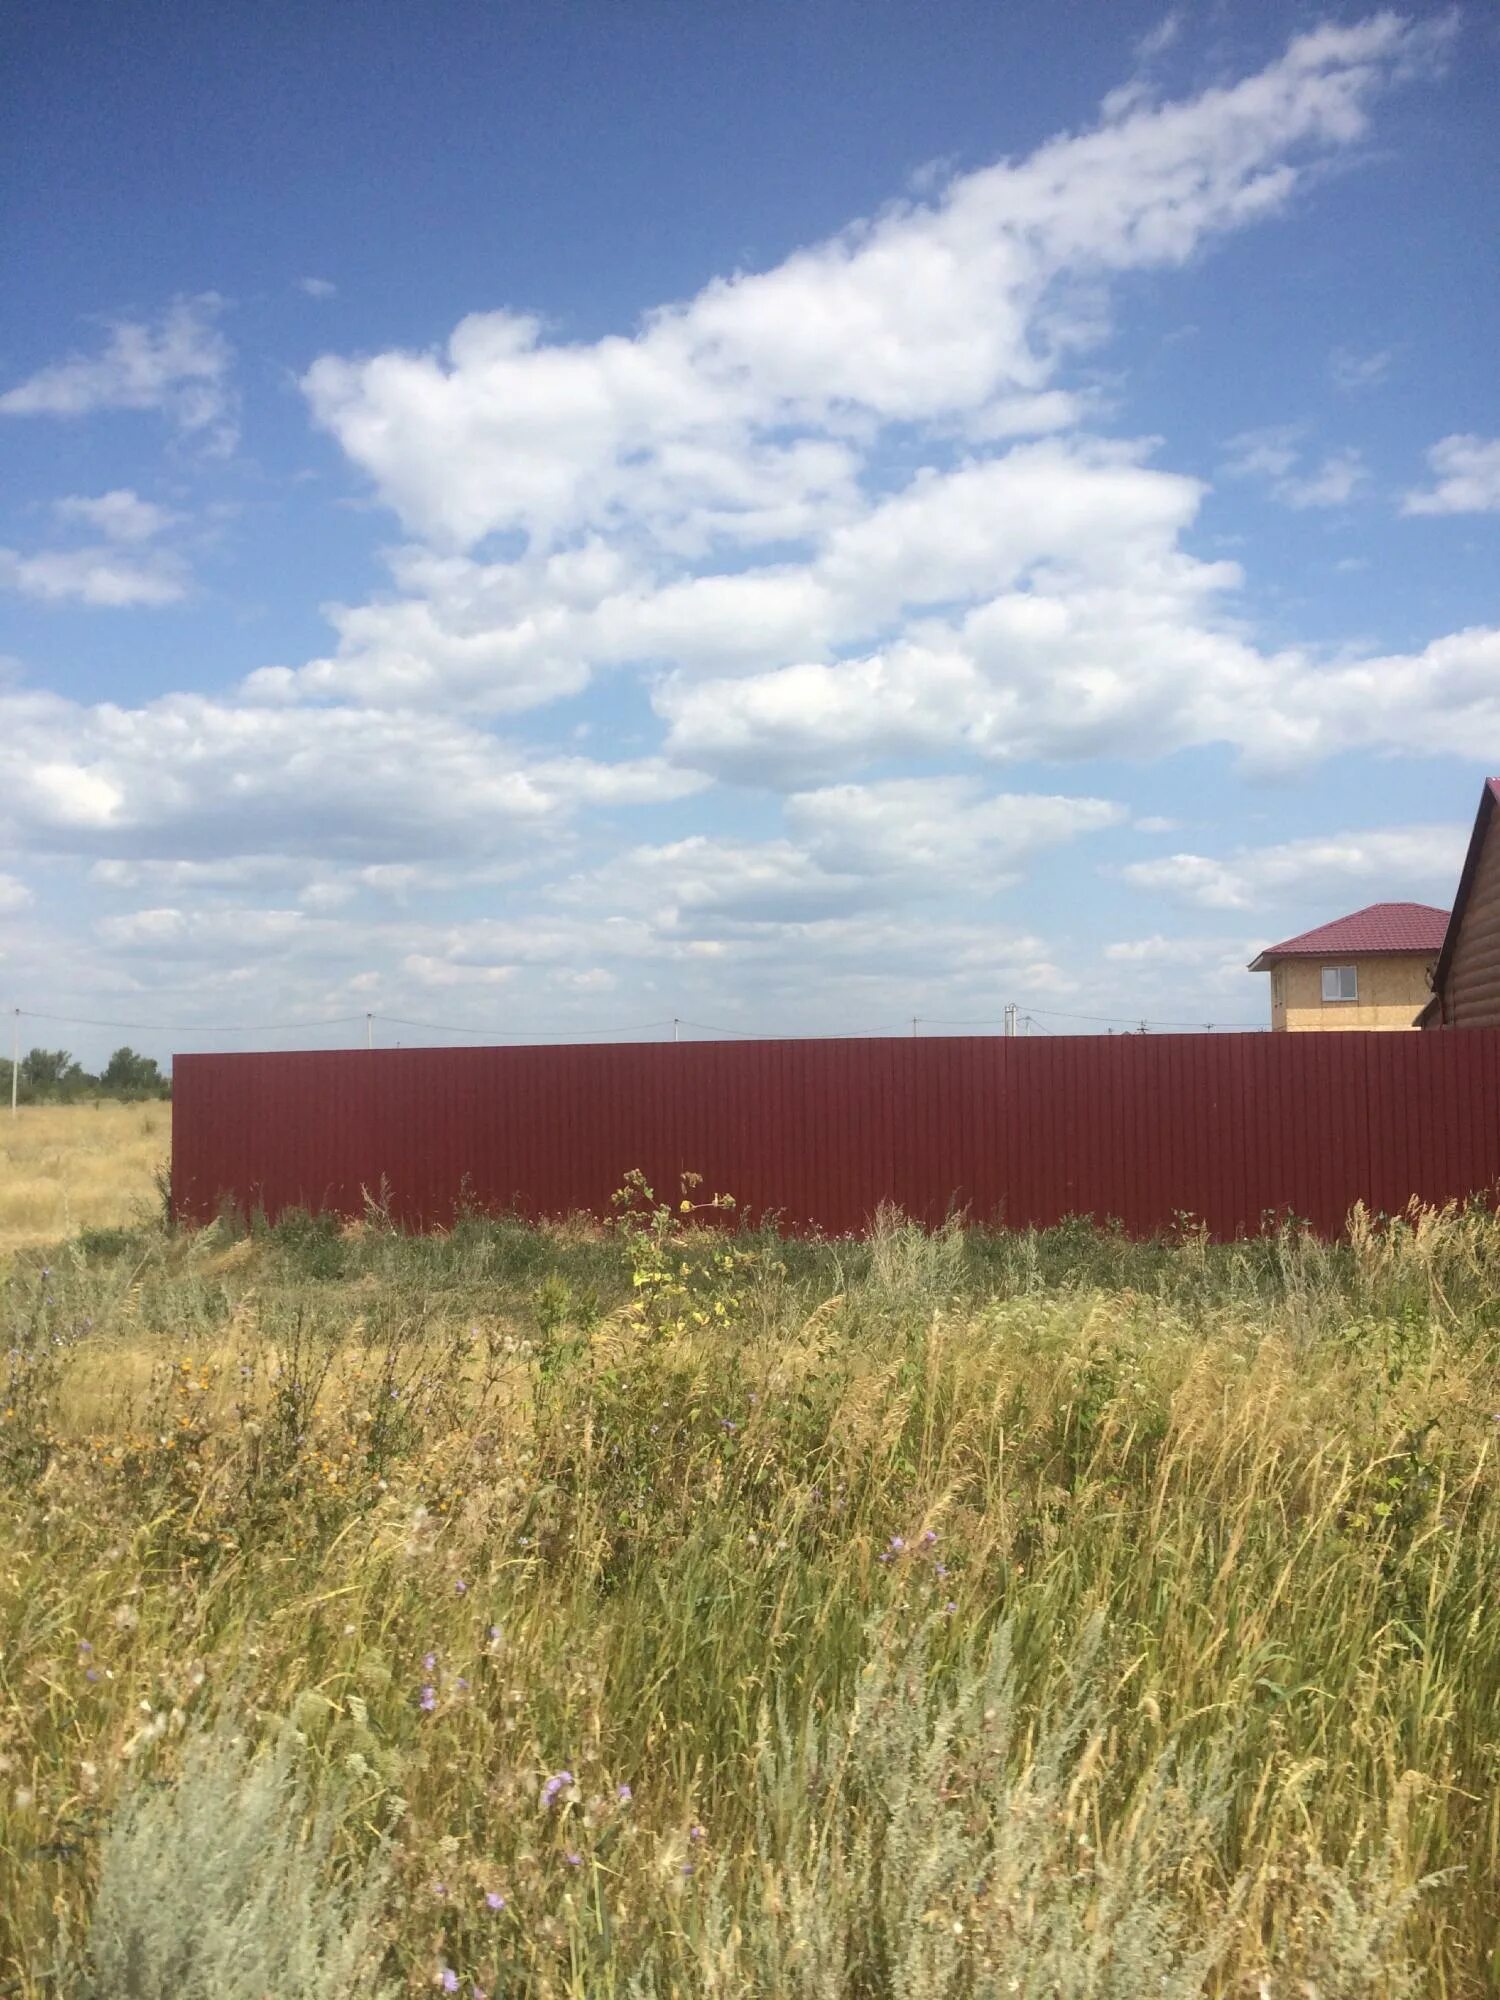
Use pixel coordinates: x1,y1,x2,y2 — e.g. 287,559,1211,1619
304,14,1440,548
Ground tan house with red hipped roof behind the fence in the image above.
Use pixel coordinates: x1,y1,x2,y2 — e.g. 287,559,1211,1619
1250,904,1448,1034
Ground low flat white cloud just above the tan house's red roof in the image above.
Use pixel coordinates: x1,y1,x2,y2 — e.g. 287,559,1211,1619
1120,826,1468,918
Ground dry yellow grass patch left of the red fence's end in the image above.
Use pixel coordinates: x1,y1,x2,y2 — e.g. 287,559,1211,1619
0,1104,172,1256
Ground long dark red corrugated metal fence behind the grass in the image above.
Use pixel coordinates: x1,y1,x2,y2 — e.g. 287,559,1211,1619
172,1028,1500,1238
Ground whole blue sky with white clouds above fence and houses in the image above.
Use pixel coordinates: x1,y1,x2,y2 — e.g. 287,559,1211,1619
0,0,1500,1056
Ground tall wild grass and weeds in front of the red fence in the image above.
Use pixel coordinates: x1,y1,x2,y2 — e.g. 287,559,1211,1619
0,1112,1500,2000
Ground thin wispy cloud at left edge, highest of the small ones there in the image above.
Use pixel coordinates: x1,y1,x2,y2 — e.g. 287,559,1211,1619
0,292,236,452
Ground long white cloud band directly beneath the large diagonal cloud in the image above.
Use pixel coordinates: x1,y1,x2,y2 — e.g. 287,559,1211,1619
248,440,1238,712
